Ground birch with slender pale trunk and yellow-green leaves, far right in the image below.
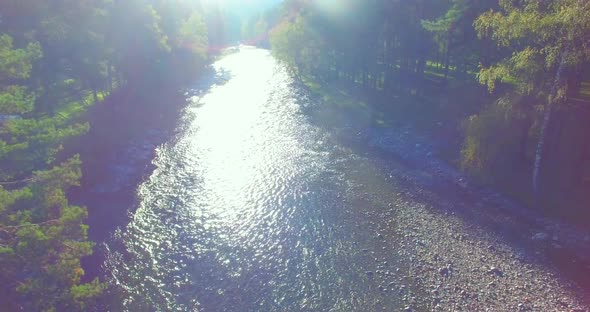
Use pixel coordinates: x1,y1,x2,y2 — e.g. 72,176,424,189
472,0,590,201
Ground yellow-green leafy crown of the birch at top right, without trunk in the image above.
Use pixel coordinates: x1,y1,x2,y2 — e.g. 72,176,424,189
474,0,590,94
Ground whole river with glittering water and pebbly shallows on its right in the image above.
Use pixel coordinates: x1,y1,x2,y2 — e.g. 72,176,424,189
93,47,590,311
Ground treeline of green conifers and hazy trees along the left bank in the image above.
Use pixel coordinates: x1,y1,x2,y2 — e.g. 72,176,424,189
0,0,208,311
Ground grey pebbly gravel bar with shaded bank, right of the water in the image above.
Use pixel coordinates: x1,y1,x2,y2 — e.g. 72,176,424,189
308,82,590,311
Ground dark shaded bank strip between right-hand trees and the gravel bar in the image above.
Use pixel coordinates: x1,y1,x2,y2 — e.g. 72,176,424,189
298,77,590,275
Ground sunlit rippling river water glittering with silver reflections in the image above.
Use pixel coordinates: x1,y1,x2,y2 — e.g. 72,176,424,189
106,49,408,311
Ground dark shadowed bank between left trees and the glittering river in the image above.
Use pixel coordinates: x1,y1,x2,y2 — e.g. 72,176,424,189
67,66,232,281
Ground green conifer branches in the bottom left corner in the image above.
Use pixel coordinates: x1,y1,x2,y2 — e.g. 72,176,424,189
0,156,102,311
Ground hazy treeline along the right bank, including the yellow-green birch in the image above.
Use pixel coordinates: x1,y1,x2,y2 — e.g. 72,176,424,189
269,0,590,218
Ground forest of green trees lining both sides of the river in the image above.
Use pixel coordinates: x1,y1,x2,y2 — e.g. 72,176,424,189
0,0,590,311
